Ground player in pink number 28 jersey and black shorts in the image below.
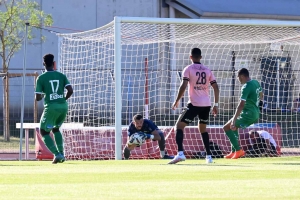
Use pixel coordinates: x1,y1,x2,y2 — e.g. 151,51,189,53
169,48,219,164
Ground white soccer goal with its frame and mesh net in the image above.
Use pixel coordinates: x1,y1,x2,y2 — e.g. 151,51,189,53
58,17,300,159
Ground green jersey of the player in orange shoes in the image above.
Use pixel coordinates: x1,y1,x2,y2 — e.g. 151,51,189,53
241,80,262,113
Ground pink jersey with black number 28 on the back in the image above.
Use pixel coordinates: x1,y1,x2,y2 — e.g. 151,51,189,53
183,62,216,107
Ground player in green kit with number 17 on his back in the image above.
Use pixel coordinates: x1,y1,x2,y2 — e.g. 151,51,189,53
35,54,73,164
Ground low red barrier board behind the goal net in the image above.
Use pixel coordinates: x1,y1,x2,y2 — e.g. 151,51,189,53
35,123,281,160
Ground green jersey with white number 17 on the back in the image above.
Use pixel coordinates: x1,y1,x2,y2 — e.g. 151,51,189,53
35,71,70,107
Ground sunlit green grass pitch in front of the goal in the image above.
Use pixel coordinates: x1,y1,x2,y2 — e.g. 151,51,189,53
0,157,300,200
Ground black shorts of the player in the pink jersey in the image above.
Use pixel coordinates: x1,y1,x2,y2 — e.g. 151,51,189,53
179,103,210,124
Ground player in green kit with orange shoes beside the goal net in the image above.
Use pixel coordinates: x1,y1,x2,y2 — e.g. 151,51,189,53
223,68,263,159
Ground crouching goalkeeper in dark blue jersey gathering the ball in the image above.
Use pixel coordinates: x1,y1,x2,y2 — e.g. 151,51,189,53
123,114,173,160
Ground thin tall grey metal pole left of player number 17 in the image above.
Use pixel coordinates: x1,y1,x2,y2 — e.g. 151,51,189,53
19,22,29,161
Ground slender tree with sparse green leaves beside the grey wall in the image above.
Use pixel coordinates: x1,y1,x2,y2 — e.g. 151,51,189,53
0,0,53,141
